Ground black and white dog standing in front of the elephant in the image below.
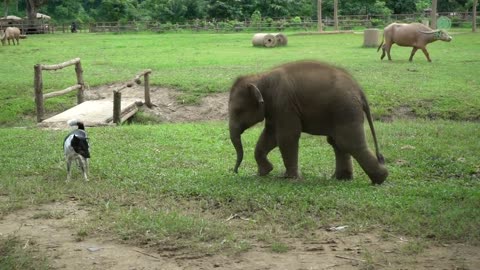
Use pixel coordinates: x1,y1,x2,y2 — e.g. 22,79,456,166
63,119,90,181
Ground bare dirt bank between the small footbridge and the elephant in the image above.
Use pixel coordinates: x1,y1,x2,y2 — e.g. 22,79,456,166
85,84,228,122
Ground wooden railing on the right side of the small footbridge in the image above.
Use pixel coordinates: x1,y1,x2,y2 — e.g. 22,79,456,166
113,69,153,124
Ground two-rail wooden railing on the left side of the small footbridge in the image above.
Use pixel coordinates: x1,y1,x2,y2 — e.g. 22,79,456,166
33,58,85,122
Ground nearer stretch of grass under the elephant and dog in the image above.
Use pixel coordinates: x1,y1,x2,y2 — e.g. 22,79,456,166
0,121,480,252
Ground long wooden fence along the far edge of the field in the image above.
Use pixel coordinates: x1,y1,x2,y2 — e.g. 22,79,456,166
82,12,480,32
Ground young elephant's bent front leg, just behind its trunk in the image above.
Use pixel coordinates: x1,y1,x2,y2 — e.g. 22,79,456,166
255,128,277,176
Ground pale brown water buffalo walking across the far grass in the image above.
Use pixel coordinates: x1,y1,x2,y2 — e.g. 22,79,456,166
377,23,452,62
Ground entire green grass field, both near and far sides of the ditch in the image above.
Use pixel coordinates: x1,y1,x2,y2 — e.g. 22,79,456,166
0,32,480,268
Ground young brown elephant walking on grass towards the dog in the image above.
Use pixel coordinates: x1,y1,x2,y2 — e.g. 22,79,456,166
228,61,388,184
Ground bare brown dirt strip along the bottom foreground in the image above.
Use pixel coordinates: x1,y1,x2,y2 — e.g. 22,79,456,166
0,200,480,270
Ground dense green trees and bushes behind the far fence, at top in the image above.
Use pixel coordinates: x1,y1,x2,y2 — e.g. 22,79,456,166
0,0,473,23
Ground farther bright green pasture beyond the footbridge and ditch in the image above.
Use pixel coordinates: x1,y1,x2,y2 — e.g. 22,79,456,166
0,30,480,126
